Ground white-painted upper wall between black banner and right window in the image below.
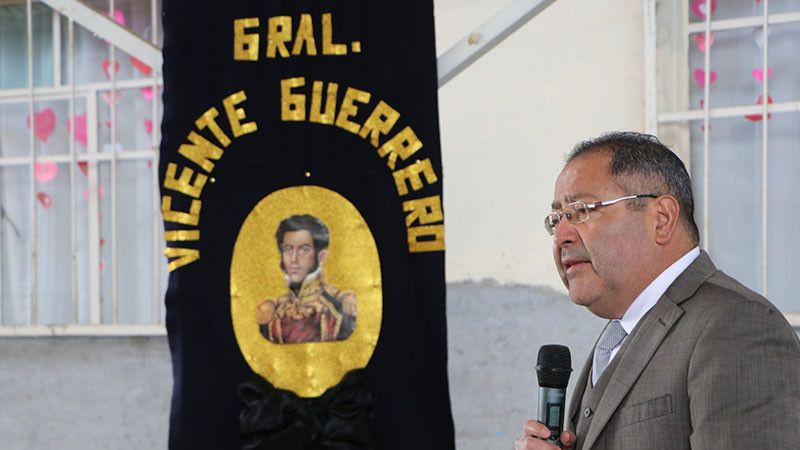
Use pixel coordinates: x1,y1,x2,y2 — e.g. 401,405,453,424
434,0,645,292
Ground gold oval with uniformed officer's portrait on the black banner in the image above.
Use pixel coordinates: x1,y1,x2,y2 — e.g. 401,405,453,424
231,186,383,397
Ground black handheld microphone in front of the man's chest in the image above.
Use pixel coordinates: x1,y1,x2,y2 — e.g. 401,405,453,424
536,344,572,447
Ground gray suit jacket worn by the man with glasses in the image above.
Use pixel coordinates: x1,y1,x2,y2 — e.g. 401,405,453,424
568,252,800,450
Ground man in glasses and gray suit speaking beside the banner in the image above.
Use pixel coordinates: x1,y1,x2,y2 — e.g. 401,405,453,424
515,133,800,450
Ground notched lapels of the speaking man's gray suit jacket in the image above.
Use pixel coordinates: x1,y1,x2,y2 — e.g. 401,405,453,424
570,251,716,450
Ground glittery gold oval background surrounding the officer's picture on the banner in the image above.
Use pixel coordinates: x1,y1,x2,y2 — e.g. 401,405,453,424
230,185,383,397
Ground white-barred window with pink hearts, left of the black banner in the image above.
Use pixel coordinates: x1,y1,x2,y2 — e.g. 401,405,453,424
0,0,167,336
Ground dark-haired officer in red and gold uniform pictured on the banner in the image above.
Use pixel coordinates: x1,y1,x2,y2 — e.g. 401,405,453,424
255,214,356,344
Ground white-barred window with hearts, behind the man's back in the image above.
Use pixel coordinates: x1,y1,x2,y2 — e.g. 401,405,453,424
644,0,800,326
